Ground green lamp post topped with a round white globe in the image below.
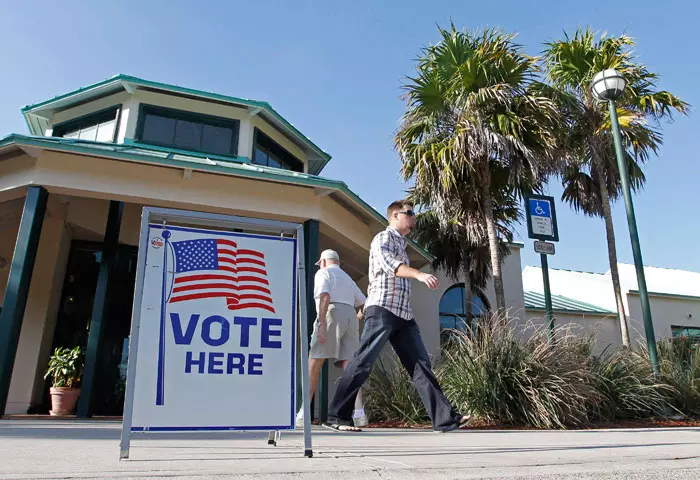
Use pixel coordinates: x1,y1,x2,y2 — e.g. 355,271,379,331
591,68,659,376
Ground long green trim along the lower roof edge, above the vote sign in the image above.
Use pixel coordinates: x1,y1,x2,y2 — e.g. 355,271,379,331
0,134,433,261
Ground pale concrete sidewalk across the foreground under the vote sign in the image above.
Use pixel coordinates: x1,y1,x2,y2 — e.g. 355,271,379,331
0,420,700,480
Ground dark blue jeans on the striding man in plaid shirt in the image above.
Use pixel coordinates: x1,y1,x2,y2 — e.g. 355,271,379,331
328,306,462,431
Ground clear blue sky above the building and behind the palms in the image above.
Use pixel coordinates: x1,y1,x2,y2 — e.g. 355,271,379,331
0,0,700,272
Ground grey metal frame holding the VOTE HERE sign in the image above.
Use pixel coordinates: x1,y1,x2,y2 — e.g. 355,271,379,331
119,207,313,460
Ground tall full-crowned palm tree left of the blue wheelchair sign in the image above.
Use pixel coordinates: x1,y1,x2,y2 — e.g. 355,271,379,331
394,25,559,311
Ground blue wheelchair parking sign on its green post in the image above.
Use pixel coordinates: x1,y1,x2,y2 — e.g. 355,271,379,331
525,195,559,343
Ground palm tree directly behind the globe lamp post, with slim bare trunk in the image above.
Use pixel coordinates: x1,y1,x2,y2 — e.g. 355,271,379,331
544,28,689,346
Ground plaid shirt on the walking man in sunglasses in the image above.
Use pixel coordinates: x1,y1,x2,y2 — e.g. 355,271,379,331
365,227,413,320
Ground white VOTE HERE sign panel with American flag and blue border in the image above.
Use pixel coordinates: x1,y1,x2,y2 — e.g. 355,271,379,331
131,225,297,431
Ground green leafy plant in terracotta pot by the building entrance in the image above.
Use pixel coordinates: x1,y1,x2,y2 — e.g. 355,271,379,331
44,347,83,415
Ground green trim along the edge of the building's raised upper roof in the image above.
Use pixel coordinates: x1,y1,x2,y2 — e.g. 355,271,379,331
22,74,331,173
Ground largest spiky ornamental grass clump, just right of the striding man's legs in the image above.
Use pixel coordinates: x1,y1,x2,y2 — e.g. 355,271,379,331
438,316,598,428
